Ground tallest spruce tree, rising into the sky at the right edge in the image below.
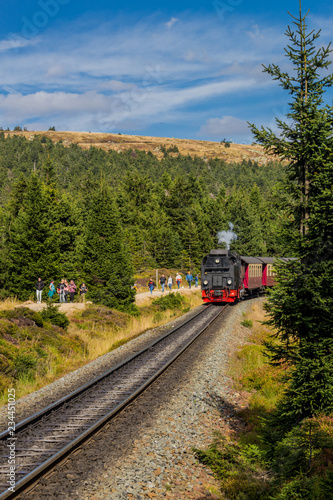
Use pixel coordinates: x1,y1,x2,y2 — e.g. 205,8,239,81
251,4,333,427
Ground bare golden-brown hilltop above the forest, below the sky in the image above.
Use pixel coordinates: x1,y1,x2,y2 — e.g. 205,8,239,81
5,130,272,165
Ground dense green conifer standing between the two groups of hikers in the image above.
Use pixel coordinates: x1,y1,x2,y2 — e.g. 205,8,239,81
82,186,134,307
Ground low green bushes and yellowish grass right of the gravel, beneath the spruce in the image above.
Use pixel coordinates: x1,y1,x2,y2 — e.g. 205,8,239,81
194,305,333,500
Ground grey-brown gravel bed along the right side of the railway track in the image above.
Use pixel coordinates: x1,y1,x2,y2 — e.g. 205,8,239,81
18,299,262,500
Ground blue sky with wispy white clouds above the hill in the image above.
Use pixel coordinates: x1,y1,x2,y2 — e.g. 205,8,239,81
0,0,333,143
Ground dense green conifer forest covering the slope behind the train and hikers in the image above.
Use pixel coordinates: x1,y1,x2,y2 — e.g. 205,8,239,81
0,132,291,308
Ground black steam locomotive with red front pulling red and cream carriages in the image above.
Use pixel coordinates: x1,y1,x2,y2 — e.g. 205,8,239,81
201,249,290,303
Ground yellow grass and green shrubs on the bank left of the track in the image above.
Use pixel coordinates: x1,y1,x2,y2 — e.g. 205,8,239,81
0,294,201,403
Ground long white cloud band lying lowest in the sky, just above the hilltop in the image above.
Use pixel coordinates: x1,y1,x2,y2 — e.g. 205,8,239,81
0,80,255,122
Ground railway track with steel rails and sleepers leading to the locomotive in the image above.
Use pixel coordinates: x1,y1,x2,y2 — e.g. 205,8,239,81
0,305,225,500
